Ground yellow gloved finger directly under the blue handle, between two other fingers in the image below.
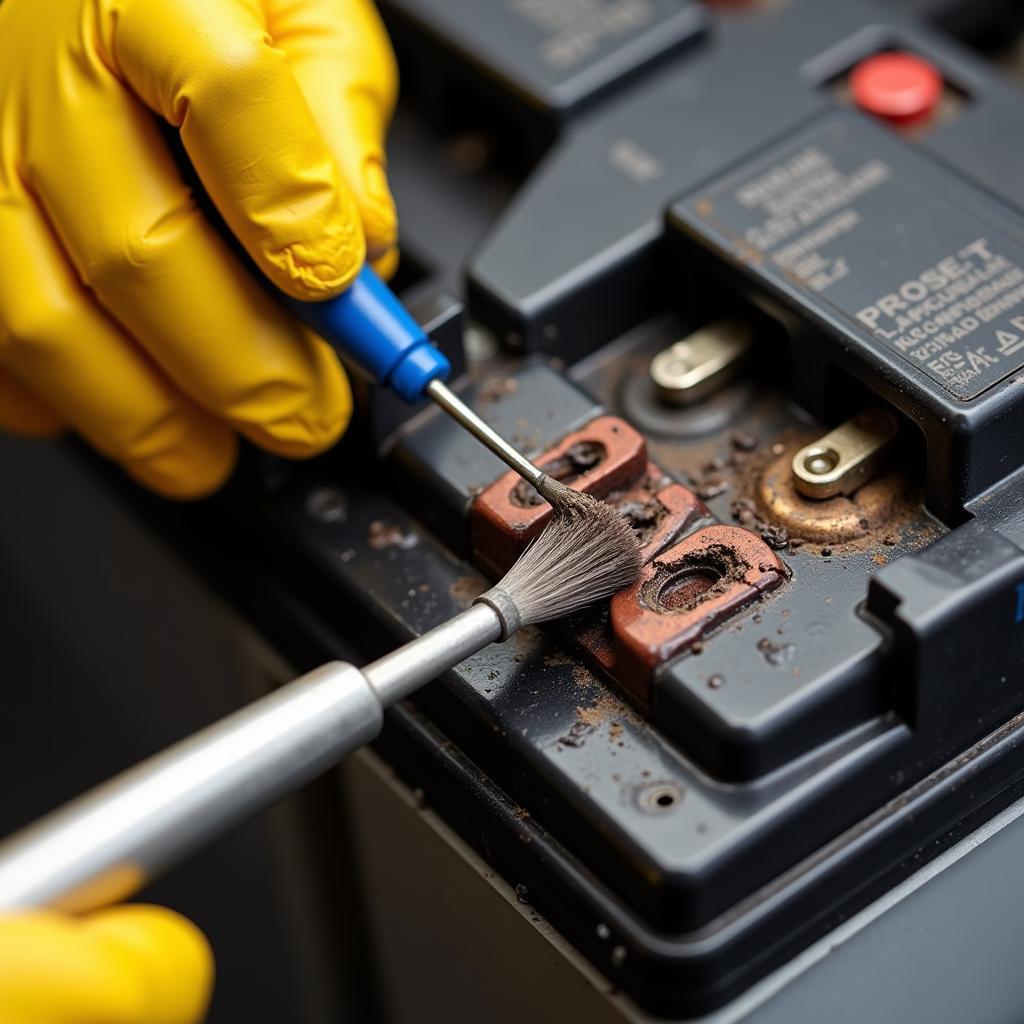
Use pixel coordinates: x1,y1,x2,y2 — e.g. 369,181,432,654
30,78,351,457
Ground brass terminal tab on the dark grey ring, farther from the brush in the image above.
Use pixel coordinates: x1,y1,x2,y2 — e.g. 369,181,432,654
650,319,753,406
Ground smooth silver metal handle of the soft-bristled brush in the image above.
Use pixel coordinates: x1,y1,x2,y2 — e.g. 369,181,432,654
0,604,506,911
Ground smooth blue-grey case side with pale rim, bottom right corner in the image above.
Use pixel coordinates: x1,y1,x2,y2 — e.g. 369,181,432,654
701,801,1024,1024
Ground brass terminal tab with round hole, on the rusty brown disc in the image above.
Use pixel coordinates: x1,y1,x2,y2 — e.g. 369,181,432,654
793,409,897,499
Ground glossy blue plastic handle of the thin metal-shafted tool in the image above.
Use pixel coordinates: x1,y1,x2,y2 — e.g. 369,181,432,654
291,266,452,401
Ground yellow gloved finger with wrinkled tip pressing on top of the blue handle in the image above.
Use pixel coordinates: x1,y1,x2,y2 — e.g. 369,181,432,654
104,0,366,299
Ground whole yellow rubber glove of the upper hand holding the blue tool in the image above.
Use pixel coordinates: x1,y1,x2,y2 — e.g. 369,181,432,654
0,0,396,497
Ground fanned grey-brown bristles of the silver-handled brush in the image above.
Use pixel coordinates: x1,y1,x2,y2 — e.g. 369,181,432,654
487,491,642,626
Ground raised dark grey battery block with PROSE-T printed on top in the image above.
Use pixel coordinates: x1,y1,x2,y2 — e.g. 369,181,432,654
670,112,1024,519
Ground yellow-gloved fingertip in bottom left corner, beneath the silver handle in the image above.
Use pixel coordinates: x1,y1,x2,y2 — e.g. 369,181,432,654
0,905,213,1024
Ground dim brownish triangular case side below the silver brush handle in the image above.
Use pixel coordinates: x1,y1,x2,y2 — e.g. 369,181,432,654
344,752,623,1024
